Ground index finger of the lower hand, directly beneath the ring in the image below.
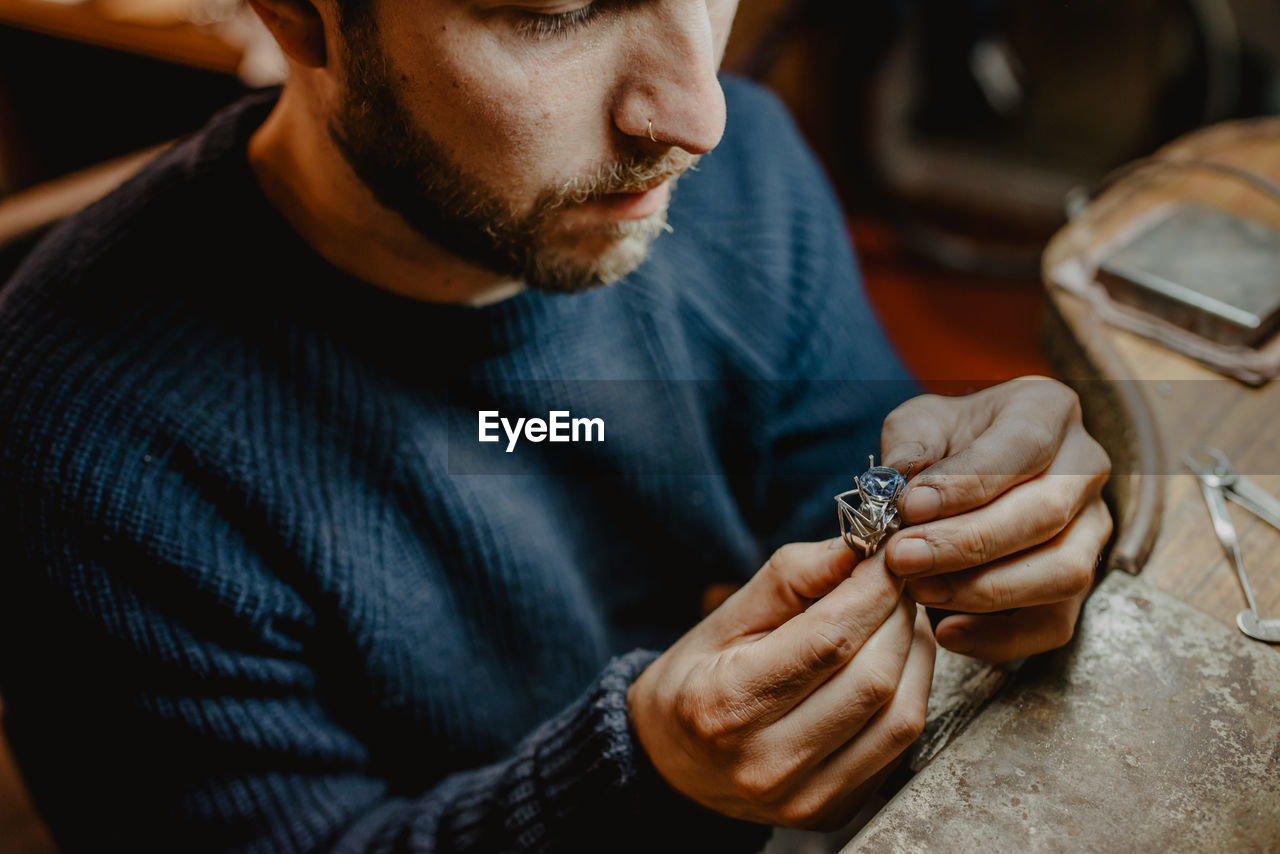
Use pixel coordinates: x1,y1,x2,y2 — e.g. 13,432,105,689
723,554,902,726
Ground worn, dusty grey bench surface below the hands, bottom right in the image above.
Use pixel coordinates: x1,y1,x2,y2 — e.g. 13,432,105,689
844,574,1280,854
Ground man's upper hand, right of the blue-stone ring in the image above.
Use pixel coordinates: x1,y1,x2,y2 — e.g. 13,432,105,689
881,378,1111,661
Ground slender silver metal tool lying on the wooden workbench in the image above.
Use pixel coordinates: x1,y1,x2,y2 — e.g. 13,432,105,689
1184,448,1280,644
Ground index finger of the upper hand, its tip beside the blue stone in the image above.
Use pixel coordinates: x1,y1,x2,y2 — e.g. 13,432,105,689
901,380,1090,525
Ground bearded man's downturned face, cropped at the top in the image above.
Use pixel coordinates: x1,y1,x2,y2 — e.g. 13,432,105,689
330,0,737,292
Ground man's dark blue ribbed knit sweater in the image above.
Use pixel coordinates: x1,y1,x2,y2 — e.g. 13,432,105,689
0,79,911,853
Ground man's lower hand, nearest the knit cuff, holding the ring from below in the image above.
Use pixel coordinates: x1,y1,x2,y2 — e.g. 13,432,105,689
627,539,936,830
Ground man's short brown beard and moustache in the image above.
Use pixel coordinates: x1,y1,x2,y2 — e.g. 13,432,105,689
329,22,698,293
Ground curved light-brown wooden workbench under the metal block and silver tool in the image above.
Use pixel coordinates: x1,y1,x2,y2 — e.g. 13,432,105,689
1043,118,1280,626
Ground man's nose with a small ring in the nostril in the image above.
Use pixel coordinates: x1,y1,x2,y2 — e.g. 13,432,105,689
613,0,724,154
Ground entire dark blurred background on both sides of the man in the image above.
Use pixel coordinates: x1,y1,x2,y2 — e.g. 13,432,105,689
0,0,1280,851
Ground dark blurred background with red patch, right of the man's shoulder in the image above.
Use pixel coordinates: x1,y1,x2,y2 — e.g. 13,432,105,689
727,0,1280,393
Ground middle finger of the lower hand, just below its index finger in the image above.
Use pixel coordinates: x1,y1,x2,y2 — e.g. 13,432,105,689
759,598,915,769
